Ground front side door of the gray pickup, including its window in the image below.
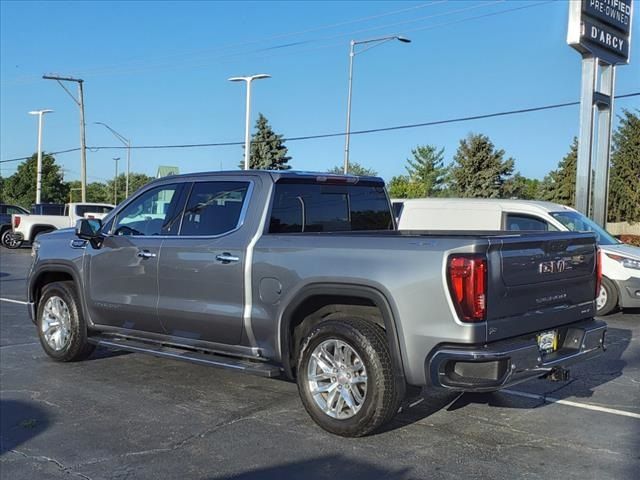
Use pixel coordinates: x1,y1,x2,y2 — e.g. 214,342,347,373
85,183,188,333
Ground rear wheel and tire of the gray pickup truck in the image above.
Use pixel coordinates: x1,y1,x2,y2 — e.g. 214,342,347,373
297,318,405,437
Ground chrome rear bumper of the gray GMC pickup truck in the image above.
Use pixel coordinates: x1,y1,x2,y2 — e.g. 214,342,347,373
425,319,607,392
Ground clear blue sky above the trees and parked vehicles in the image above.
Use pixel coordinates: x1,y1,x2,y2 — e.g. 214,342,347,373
0,0,640,186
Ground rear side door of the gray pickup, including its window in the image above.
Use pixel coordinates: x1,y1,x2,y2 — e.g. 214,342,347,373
158,177,255,345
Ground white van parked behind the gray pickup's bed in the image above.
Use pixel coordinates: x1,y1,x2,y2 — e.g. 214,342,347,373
392,198,640,315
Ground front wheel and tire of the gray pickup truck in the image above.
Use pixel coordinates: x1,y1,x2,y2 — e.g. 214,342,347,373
36,282,95,362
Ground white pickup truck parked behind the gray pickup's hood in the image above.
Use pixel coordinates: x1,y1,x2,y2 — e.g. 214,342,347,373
6,203,114,248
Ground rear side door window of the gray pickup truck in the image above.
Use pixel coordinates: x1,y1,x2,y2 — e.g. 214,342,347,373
180,182,249,235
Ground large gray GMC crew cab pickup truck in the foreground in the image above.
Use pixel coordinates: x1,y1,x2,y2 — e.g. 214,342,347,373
28,171,606,436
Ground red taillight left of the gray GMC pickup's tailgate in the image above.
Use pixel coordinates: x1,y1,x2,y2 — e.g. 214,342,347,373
448,255,487,322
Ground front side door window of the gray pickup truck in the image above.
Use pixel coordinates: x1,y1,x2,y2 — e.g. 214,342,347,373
113,184,182,235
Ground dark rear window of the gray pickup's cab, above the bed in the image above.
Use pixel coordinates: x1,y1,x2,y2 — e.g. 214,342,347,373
269,183,393,233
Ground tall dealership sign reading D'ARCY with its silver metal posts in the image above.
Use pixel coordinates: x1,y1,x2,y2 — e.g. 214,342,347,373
567,0,633,226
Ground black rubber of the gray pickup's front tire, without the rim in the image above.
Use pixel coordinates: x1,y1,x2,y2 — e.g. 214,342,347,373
36,282,93,362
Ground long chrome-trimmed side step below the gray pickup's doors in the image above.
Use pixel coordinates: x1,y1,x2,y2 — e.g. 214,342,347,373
87,335,280,378
